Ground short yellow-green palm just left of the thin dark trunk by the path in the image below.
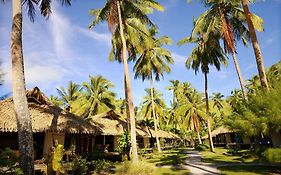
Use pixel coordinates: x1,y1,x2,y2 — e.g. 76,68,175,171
176,89,206,144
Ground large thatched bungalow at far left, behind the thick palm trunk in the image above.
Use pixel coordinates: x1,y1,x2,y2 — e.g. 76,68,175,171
0,87,97,159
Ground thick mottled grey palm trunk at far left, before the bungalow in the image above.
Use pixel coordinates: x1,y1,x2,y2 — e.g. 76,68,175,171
11,0,34,175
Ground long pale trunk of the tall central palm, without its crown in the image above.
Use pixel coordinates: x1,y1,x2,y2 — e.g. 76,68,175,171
117,0,138,163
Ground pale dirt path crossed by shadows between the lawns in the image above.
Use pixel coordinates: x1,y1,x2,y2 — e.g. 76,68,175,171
185,151,221,175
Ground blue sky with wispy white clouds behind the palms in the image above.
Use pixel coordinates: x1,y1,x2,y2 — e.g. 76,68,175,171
0,0,281,105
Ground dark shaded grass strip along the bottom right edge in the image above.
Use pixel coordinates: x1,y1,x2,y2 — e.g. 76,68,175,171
218,165,281,175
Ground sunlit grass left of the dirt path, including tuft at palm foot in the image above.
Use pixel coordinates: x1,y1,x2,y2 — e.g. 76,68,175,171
112,149,189,175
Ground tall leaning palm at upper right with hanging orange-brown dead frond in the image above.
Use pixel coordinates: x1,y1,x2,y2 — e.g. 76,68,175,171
192,0,263,101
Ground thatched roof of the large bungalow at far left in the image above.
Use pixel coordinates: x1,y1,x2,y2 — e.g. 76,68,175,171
0,87,96,134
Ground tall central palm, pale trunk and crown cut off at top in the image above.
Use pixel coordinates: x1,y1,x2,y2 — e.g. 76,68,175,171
87,0,163,163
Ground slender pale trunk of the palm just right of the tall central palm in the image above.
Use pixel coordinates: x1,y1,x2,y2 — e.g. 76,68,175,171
150,75,161,152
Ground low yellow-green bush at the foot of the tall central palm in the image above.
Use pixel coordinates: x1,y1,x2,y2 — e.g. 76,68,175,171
116,162,155,175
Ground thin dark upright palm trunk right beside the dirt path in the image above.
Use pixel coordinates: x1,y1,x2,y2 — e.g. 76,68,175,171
204,72,215,152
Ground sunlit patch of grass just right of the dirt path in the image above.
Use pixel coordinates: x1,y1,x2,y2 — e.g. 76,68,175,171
201,148,259,164
